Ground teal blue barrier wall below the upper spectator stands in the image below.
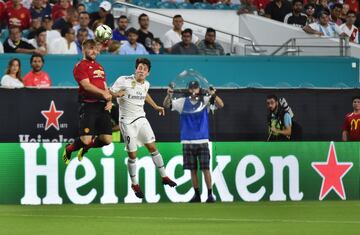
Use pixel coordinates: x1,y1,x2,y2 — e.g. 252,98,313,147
0,54,360,88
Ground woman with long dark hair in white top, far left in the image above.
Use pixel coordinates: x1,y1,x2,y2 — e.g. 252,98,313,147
1,58,24,88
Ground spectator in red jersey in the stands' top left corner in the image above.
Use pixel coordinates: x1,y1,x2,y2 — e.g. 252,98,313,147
6,0,30,29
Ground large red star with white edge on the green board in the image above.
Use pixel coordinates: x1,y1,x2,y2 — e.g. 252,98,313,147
311,142,353,200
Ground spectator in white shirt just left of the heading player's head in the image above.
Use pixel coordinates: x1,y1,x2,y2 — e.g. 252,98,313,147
49,25,78,55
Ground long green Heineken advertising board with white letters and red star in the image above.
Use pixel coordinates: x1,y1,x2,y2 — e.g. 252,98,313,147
0,142,360,205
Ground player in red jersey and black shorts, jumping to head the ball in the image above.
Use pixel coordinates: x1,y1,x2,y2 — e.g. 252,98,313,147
63,39,112,164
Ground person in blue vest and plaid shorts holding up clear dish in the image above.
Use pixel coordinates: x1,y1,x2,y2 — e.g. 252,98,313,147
164,81,224,203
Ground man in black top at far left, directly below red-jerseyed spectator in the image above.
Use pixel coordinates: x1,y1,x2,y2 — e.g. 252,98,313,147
4,26,44,54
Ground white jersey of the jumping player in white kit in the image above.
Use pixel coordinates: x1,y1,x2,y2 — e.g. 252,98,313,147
110,75,150,123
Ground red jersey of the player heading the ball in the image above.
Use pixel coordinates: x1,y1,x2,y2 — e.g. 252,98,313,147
73,60,106,102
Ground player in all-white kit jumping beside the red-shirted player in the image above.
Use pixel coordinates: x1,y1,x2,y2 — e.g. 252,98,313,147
110,58,176,198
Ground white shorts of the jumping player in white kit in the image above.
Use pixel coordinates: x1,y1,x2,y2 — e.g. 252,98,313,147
120,117,155,152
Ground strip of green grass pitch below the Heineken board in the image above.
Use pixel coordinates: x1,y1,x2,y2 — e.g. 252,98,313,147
0,201,360,235
